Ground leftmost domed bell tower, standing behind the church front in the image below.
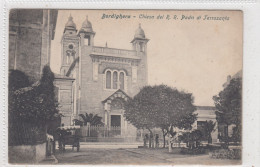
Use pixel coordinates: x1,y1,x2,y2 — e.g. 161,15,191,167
60,15,79,76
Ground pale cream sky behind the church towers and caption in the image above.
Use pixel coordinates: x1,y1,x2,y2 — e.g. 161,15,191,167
50,10,243,106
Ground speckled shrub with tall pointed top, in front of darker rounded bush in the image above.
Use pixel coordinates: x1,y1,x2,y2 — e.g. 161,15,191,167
10,66,58,126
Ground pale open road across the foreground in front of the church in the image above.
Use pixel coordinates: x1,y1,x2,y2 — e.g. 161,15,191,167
50,143,241,165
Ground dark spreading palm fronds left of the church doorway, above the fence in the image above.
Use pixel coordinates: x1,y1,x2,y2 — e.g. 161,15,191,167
74,113,104,126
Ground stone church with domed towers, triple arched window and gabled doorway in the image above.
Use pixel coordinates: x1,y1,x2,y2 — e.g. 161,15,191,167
59,16,149,135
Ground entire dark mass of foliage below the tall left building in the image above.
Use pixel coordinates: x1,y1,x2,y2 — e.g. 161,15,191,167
8,66,59,145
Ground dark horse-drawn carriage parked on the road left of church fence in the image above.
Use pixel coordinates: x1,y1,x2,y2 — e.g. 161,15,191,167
58,126,80,152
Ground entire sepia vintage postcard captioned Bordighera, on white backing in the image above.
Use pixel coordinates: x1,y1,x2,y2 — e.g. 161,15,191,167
7,9,244,165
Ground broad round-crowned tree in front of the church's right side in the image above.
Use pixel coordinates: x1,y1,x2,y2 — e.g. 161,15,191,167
124,85,196,146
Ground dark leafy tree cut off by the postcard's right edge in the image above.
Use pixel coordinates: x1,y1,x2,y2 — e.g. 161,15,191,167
213,78,242,144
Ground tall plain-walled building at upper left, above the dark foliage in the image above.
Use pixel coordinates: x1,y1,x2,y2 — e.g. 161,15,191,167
9,9,58,81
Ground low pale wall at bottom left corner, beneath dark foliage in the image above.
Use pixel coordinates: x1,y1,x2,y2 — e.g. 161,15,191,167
8,143,46,164
